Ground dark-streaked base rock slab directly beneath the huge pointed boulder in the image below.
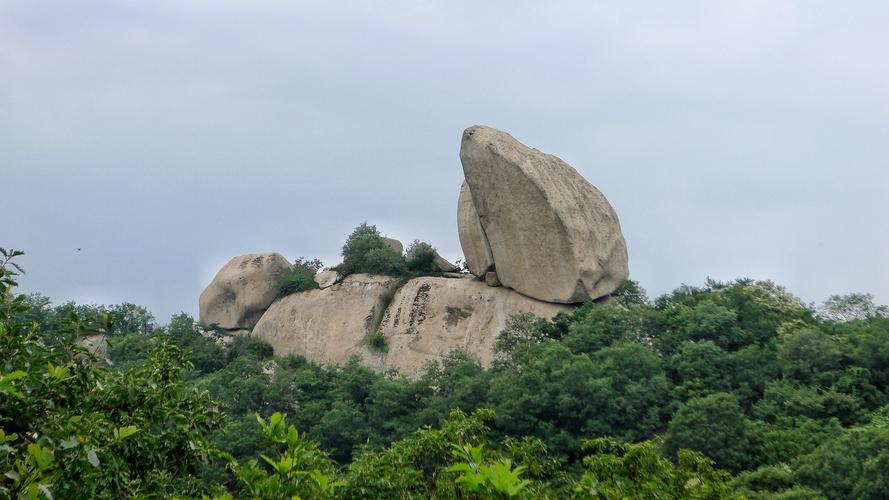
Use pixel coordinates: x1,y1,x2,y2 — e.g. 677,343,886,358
370,277,572,375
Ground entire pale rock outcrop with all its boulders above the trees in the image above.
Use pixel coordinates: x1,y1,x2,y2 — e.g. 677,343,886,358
200,126,628,376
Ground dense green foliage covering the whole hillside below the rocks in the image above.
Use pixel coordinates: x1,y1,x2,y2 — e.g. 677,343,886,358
0,248,889,498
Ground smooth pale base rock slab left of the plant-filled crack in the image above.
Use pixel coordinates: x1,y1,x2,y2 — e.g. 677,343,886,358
253,274,397,366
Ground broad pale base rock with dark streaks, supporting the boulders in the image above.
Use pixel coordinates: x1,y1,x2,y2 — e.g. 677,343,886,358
251,274,572,376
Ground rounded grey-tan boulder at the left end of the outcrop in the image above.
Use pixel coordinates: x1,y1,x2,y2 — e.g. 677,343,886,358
199,253,290,330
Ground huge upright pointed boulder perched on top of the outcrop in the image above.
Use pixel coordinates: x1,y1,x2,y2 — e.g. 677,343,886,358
460,126,629,303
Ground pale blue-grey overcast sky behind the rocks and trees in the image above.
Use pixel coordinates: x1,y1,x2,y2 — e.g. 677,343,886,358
0,0,889,322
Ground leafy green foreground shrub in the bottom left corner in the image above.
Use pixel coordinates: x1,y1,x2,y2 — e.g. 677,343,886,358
0,249,223,499
